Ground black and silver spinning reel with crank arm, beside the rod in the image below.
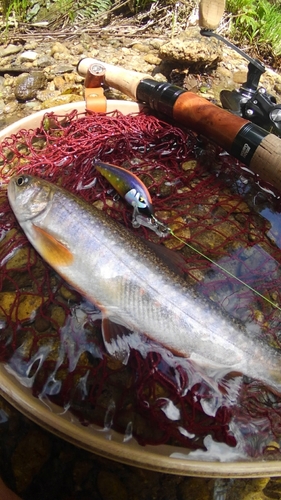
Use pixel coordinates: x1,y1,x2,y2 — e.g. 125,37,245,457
200,28,281,136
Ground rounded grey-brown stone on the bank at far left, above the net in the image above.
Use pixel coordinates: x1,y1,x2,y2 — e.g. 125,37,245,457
15,71,47,102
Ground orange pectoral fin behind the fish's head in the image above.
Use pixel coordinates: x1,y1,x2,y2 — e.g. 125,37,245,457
33,224,74,269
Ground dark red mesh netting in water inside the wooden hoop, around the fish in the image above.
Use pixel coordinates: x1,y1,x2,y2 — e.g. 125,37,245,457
0,111,281,458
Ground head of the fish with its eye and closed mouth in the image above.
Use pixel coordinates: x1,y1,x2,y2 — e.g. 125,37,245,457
8,174,53,223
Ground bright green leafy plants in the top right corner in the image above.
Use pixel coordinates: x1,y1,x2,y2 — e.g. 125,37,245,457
227,0,281,56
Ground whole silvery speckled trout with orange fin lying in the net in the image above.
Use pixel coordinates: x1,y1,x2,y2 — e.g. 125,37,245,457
8,174,281,392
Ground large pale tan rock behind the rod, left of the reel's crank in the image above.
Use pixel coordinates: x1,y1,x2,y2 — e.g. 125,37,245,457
159,28,222,70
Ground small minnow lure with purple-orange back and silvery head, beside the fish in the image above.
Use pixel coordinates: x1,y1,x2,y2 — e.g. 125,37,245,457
94,161,169,237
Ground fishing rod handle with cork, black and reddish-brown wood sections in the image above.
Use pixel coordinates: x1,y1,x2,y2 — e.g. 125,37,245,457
77,58,281,192
